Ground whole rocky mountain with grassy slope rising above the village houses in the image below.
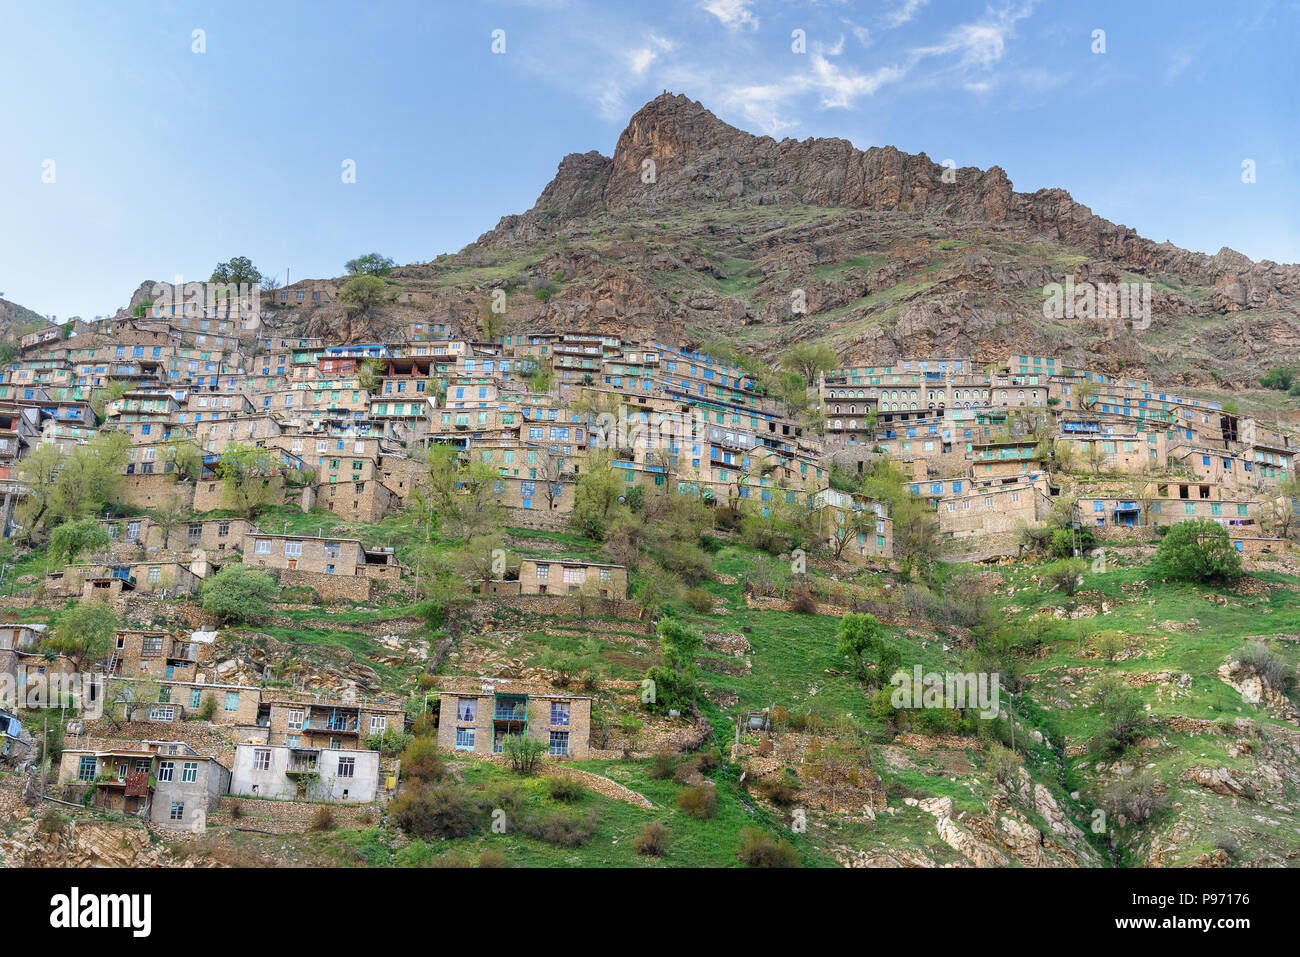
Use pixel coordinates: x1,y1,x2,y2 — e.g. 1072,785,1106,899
454,94,1300,387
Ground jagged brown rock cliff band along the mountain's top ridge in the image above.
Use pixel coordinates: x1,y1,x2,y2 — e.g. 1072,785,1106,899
480,94,1300,299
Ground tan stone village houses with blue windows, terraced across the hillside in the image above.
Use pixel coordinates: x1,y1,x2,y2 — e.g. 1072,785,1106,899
0,282,1295,830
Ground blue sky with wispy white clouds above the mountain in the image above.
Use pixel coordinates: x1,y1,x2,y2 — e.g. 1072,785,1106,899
0,0,1300,319
